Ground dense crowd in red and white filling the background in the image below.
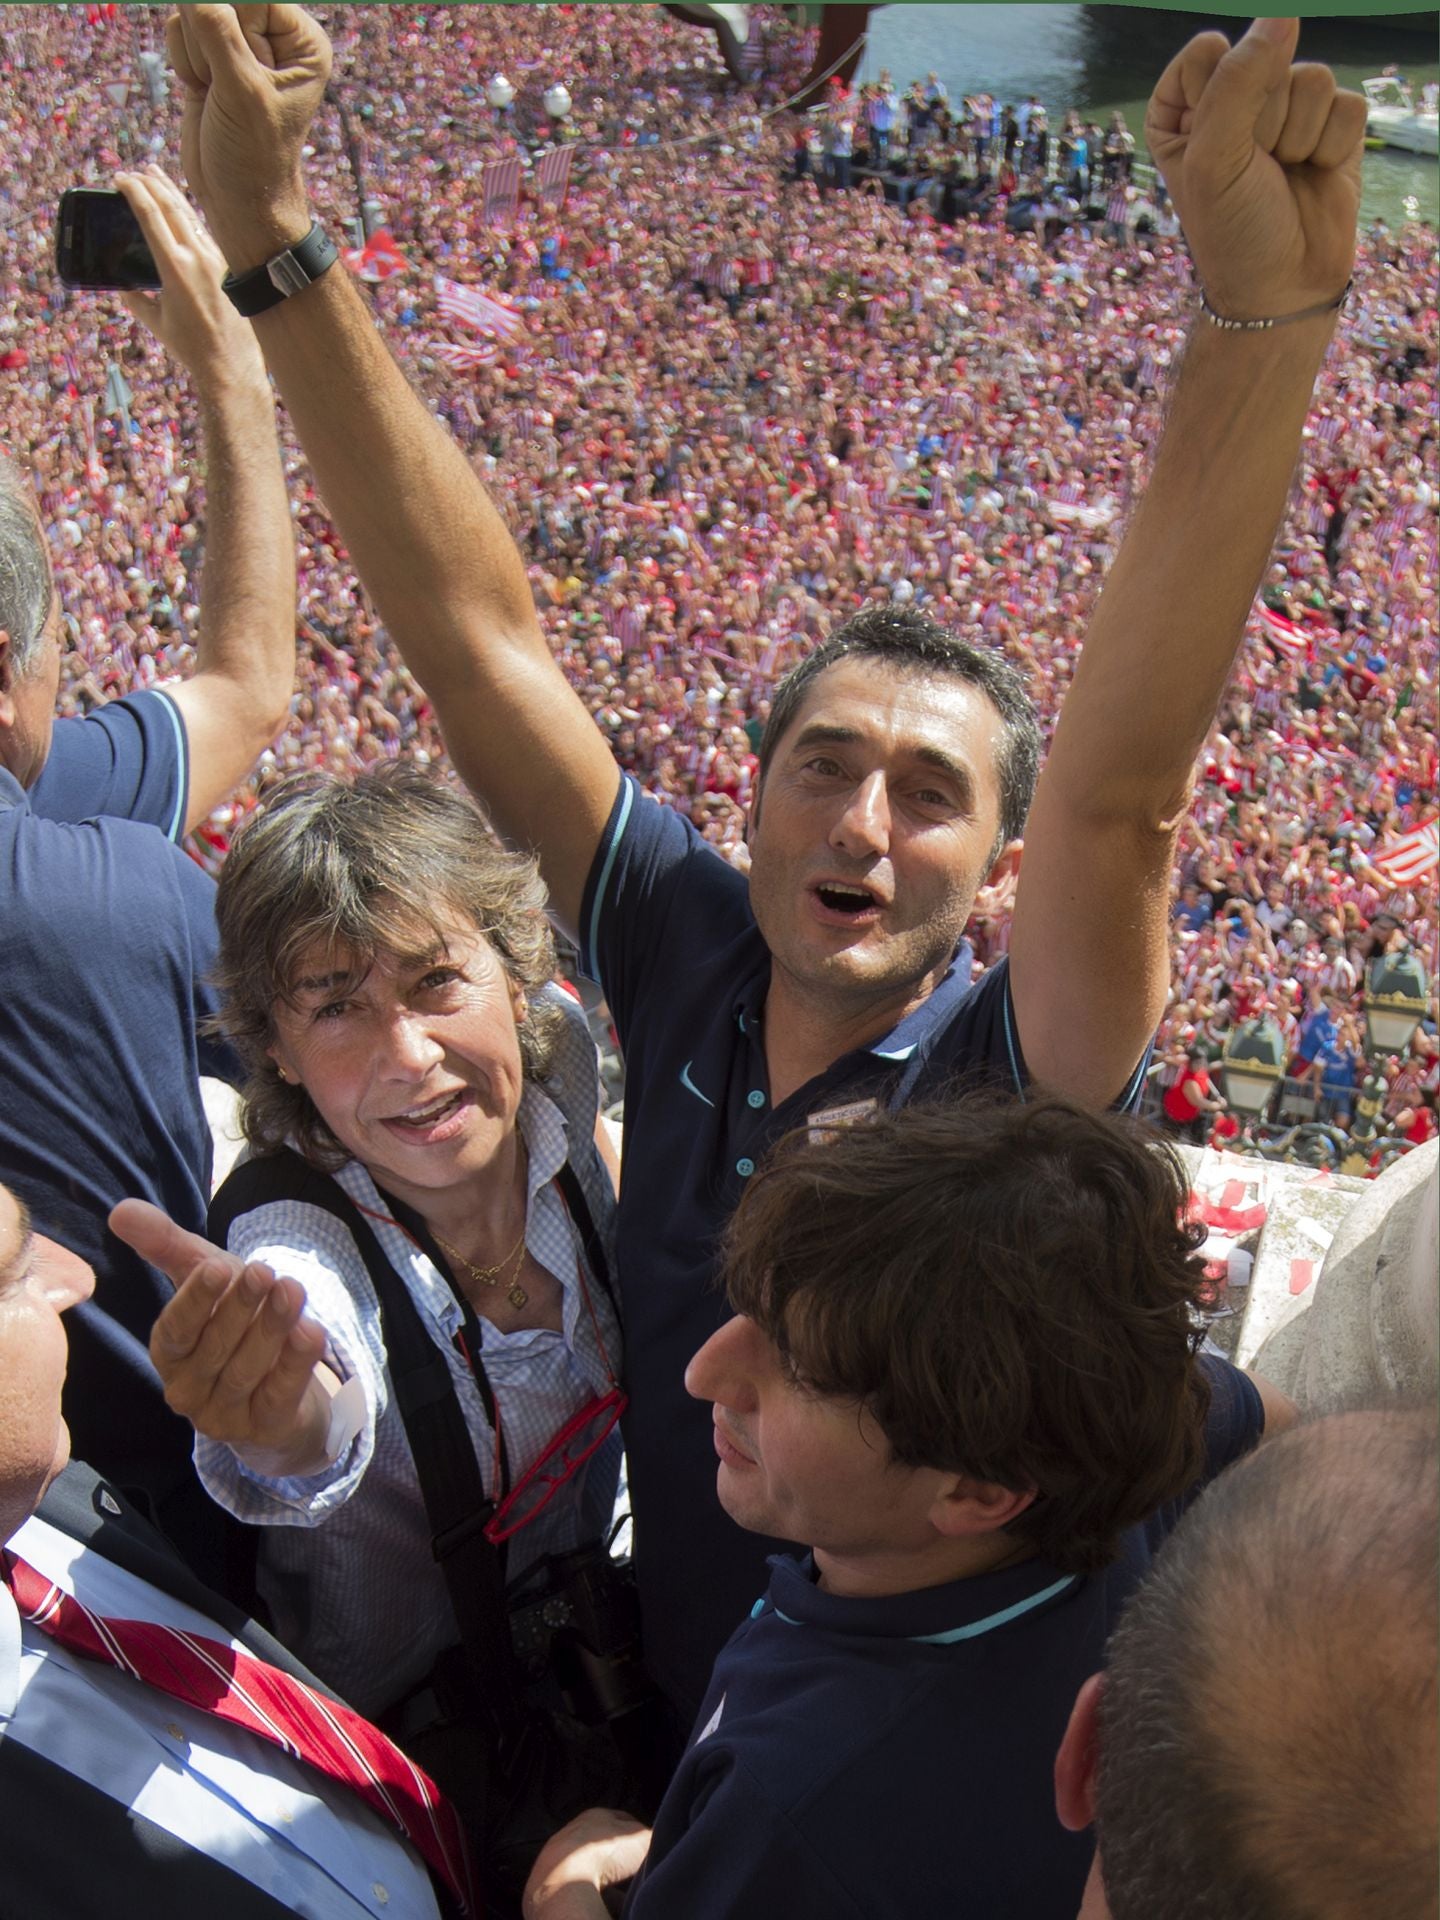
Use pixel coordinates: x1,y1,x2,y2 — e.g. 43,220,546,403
0,6,1438,1116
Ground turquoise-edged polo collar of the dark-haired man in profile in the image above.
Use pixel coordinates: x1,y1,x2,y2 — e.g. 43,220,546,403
768,1553,1085,1645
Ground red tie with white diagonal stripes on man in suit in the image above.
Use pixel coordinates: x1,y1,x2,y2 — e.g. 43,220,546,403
0,1551,478,1914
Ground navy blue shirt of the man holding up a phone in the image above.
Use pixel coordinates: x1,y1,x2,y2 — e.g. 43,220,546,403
0,695,238,1582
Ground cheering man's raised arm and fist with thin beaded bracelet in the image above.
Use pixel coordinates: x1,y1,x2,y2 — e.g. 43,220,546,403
1010,15,1365,1104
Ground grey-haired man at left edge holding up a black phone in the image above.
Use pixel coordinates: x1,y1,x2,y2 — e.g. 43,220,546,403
0,169,296,1578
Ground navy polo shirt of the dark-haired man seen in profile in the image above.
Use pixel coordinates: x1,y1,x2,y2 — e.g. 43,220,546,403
624,1359,1263,1920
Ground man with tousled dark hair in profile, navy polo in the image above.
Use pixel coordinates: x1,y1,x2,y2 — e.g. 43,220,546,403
526,1096,1294,1920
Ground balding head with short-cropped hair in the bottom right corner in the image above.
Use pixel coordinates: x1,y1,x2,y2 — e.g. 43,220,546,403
1096,1409,1440,1920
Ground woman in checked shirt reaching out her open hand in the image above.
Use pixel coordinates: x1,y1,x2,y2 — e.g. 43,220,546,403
117,764,622,1881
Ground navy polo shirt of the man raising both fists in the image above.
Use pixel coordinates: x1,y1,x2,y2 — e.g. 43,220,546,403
580,778,1159,1718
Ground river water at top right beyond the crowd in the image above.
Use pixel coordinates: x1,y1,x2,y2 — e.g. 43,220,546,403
858,4,1440,227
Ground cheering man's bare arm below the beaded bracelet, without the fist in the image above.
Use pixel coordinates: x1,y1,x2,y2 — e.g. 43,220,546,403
1010,307,1331,1104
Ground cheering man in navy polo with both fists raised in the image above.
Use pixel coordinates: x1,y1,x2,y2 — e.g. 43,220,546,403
157,6,1365,1713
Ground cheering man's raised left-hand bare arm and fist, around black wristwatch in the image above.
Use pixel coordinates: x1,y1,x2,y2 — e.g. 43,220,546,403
165,6,620,927
